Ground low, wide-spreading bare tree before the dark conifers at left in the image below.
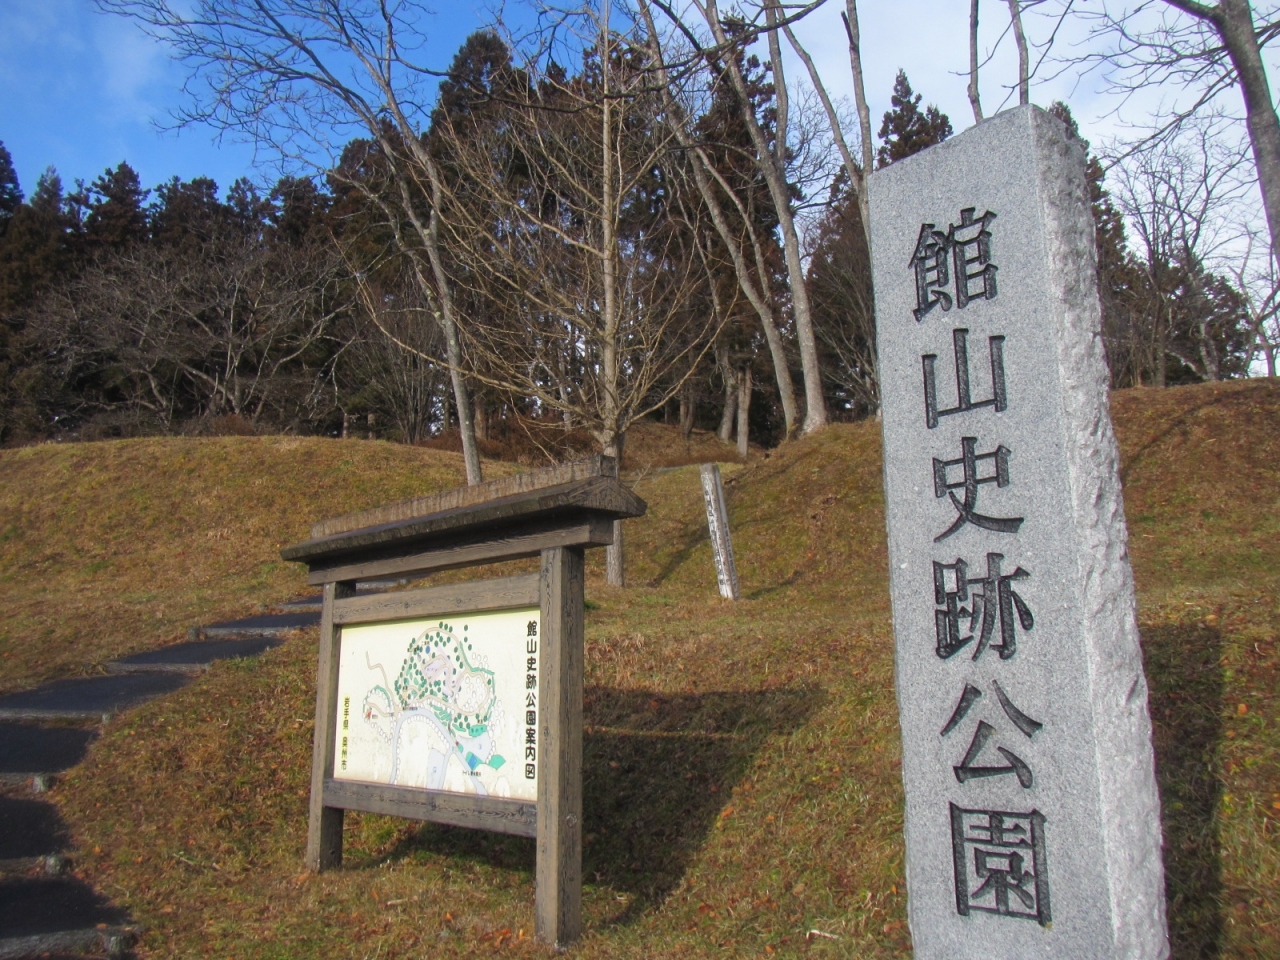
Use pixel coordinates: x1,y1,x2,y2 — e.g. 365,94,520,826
29,232,346,429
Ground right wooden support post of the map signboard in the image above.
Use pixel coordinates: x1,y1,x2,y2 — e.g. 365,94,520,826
534,547,582,948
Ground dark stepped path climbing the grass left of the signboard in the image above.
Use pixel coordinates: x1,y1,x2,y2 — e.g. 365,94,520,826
0,599,325,960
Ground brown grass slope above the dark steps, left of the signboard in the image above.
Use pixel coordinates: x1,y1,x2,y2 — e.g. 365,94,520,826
0,436,511,692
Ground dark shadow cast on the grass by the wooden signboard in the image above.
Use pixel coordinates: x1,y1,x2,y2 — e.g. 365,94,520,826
389,686,826,923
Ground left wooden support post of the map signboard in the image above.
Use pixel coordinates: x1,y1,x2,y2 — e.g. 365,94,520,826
306,581,356,873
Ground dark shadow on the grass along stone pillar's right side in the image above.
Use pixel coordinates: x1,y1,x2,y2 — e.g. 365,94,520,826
1142,625,1225,960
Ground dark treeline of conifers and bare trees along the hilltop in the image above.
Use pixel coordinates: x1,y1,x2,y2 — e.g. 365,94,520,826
0,29,1256,452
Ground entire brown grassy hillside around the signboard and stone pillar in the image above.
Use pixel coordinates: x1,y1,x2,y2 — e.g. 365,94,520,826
0,381,1280,959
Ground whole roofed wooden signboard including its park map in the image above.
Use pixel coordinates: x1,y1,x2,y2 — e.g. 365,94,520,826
282,457,645,946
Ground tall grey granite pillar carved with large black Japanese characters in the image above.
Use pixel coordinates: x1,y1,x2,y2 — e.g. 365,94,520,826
869,106,1169,960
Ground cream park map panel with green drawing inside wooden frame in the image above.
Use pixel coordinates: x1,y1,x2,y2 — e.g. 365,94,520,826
333,607,540,801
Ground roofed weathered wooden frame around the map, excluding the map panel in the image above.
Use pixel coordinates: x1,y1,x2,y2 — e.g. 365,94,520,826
290,457,645,947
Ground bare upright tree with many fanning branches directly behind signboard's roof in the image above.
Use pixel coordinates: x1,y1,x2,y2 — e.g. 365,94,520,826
433,3,717,585
